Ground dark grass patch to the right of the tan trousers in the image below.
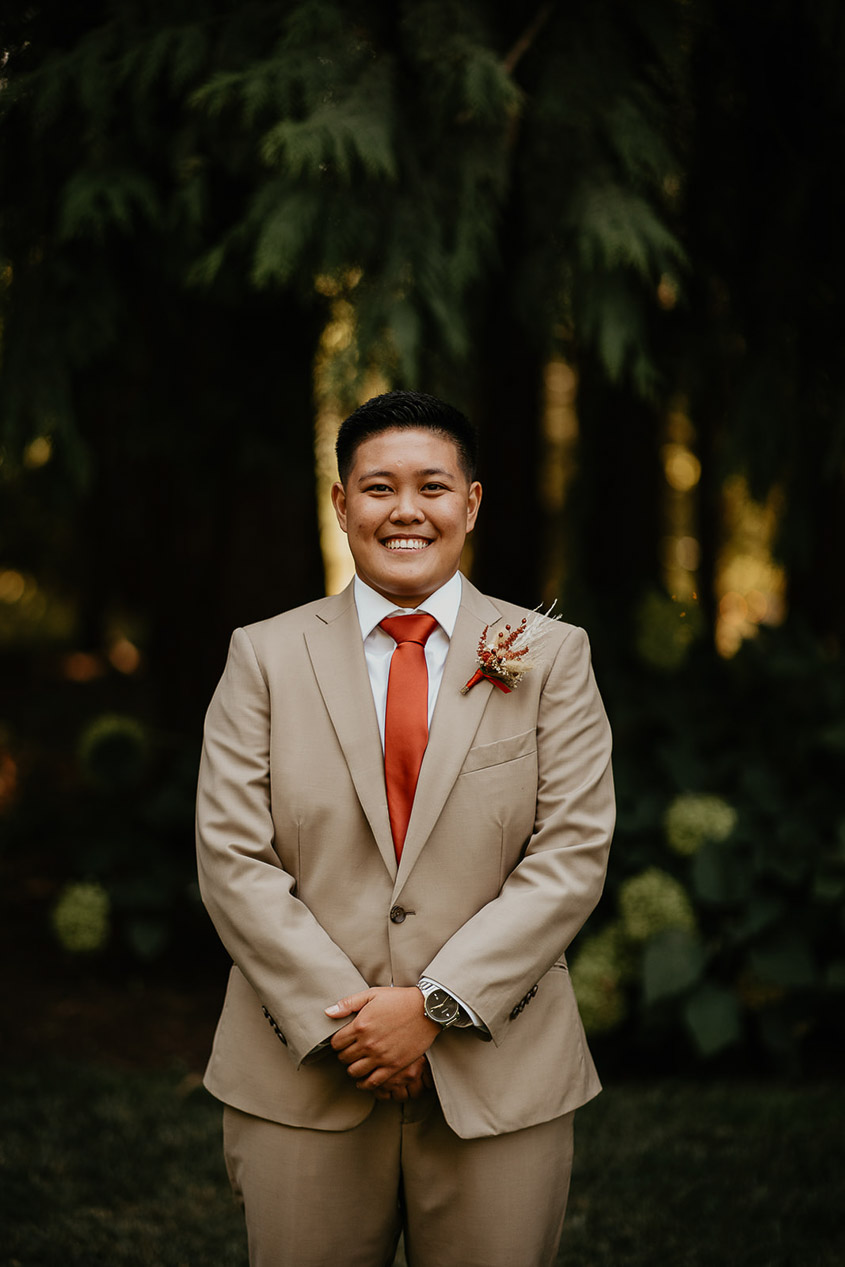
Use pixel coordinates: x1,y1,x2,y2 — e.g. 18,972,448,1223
560,1082,845,1267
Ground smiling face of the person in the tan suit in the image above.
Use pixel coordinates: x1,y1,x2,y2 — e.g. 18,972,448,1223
332,427,481,607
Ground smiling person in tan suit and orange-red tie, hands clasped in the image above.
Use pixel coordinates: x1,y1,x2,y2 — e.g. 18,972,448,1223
198,392,614,1267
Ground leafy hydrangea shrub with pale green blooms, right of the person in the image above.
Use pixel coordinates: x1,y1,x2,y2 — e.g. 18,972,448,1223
571,628,845,1071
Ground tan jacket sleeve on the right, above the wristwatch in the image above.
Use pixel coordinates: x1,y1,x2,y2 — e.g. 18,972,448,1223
426,627,616,1045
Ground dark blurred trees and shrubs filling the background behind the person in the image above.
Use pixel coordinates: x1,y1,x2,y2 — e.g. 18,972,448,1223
0,0,845,1071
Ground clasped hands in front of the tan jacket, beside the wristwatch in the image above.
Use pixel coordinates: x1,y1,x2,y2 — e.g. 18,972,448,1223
326,986,440,1100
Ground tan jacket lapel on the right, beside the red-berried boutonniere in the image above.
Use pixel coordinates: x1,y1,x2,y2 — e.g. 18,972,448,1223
397,578,500,892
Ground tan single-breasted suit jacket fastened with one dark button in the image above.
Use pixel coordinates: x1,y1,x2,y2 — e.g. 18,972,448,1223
198,580,614,1138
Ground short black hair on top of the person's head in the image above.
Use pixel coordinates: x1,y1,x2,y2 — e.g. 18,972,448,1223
334,392,478,484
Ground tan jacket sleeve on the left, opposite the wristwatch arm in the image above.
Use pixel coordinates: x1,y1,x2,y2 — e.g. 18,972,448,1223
196,630,367,1064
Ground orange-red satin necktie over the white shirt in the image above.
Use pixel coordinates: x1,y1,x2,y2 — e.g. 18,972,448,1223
380,612,437,862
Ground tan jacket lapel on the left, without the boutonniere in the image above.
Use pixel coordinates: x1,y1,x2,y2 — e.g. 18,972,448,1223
305,584,397,877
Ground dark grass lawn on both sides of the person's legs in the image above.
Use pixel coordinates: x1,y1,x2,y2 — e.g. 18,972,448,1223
0,1062,845,1267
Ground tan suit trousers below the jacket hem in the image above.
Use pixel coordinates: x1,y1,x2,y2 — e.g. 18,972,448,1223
223,1092,574,1267
